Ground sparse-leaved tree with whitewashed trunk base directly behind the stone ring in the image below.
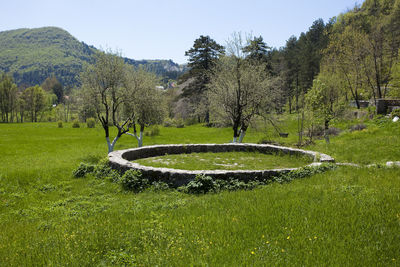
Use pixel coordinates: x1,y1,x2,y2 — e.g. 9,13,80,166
208,34,272,143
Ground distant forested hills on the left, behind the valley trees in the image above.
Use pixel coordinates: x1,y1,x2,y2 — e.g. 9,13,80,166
0,27,183,87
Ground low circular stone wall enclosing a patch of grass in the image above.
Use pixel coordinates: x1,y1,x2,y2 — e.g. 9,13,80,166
108,144,334,187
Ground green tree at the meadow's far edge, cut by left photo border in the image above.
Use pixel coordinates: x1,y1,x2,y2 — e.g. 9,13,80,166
0,73,17,122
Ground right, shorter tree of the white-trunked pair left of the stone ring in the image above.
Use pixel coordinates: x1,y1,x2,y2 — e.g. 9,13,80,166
124,68,166,147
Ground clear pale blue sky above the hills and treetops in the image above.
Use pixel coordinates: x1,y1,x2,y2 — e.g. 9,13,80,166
0,0,362,63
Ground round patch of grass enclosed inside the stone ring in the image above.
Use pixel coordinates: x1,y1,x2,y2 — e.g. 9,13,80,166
133,152,312,170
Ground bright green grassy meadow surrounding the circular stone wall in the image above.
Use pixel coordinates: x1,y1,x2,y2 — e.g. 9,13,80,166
0,118,400,266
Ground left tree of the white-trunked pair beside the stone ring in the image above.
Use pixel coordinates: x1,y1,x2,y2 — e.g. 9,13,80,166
81,52,133,152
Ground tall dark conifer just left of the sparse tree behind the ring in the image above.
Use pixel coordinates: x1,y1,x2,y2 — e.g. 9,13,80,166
183,35,224,122
